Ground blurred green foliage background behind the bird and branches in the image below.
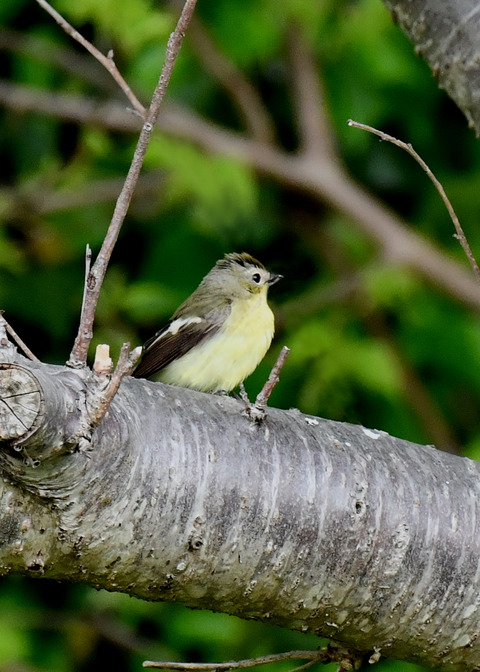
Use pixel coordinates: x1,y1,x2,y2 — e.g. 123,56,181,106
0,0,480,672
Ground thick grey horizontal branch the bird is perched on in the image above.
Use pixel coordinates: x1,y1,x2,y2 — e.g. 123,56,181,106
0,350,480,671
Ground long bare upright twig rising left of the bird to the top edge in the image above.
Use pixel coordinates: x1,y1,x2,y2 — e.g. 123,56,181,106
65,0,196,367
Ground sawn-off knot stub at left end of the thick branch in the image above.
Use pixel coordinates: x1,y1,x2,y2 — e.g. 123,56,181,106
0,356,91,498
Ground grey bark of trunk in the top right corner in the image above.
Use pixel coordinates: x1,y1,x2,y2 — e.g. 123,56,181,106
384,0,480,137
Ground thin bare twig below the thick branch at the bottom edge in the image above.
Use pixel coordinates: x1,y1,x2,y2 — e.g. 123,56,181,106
143,647,331,672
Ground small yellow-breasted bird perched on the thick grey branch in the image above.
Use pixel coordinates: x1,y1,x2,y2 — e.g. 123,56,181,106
132,252,283,392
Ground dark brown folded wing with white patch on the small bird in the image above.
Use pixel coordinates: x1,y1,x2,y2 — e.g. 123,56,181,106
132,317,222,378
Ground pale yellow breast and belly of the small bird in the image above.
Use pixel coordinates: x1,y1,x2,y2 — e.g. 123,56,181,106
159,291,274,392
